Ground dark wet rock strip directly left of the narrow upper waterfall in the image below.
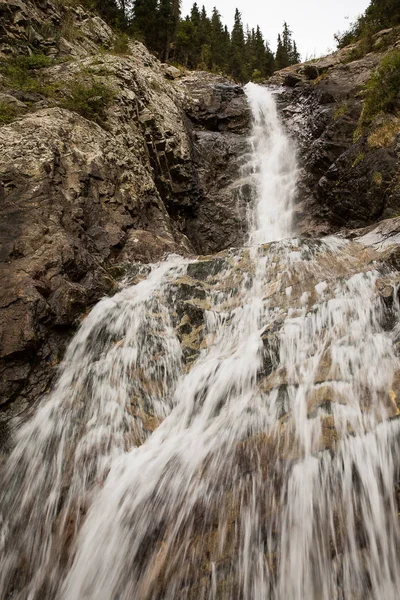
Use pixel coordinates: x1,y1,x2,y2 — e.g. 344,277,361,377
182,73,251,253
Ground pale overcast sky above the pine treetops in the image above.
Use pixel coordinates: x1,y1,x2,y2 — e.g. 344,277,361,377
182,0,369,60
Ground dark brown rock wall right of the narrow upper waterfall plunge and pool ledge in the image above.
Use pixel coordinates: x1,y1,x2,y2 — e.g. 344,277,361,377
269,28,400,235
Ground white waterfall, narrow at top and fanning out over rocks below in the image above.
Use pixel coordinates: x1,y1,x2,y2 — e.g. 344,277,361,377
0,84,400,600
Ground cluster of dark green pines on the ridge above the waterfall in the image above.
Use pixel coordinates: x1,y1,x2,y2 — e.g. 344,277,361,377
88,0,290,83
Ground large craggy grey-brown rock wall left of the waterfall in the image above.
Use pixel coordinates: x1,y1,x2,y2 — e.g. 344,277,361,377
0,0,249,434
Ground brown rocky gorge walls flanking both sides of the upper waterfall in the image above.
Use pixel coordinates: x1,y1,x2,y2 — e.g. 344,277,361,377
0,0,400,446
